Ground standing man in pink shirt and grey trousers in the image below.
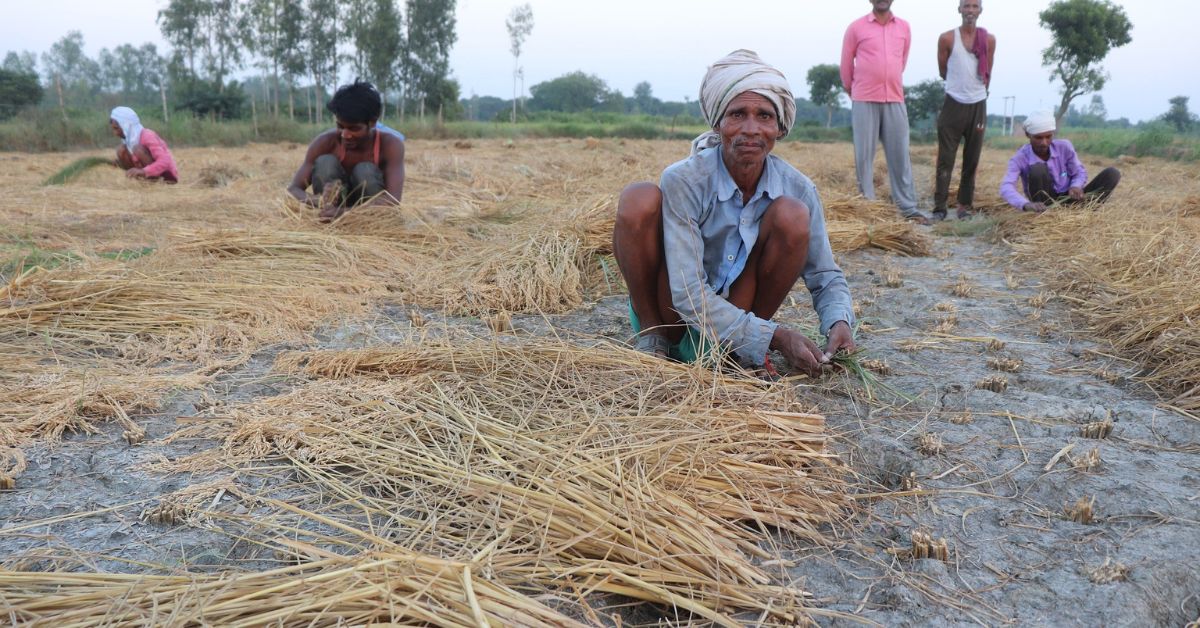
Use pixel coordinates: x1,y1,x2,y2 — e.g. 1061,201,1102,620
841,0,929,225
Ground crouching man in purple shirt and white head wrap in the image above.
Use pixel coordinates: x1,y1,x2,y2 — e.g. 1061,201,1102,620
1000,112,1121,214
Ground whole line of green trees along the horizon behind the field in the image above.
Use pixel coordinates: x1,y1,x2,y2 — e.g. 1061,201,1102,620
0,0,1198,134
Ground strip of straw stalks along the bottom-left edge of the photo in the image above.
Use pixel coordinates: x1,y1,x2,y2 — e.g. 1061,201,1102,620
0,552,583,627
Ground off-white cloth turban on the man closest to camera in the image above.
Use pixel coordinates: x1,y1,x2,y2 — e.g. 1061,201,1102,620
691,49,796,155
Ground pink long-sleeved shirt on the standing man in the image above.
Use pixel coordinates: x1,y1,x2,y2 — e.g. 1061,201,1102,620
841,12,912,102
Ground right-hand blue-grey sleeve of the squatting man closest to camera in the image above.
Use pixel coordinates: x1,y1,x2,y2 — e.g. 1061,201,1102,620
800,186,854,335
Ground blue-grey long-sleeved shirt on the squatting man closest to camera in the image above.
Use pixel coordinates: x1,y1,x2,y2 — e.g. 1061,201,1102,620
659,146,854,364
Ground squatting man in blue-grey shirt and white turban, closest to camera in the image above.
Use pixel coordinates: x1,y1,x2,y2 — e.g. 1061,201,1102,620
613,50,854,376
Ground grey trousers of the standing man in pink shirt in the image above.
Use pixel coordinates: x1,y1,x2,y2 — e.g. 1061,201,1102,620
851,101,919,216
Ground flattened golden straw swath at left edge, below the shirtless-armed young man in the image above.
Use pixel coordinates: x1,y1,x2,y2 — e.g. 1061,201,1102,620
0,231,432,365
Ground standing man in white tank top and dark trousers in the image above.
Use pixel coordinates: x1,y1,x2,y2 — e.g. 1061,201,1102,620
934,0,996,220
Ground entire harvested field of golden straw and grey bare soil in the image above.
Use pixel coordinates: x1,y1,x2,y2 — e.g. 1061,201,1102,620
0,139,1200,626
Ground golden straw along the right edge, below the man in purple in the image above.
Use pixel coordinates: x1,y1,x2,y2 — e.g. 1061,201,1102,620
1004,186,1200,412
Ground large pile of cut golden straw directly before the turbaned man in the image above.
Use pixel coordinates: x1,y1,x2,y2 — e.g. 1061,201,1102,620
147,340,848,626
